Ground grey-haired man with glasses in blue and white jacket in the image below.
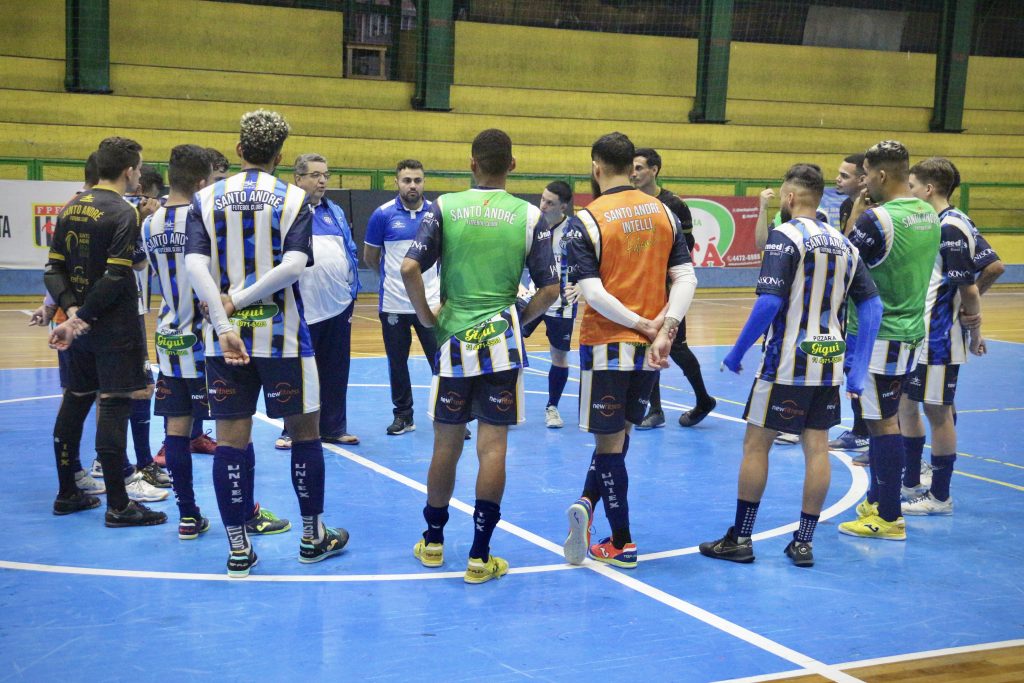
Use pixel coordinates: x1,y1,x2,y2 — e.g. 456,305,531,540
274,154,359,450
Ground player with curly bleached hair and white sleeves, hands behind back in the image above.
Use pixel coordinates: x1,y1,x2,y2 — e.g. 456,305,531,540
185,110,348,577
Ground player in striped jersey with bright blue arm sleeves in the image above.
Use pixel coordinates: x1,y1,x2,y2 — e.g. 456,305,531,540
699,164,882,566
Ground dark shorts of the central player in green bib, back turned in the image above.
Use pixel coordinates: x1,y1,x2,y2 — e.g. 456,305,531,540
427,370,525,425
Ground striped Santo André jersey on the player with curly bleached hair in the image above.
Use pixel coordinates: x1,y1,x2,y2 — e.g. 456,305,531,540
185,169,313,358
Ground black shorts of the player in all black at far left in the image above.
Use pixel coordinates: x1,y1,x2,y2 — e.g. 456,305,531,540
62,334,153,393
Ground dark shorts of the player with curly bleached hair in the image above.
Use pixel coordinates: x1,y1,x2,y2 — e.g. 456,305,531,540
206,355,319,420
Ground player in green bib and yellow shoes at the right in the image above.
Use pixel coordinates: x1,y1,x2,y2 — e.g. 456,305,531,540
839,140,941,541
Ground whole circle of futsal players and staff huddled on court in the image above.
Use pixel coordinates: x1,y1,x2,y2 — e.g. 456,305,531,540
37,110,1001,584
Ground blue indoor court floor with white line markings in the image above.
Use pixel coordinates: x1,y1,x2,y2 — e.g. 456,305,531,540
0,341,1024,683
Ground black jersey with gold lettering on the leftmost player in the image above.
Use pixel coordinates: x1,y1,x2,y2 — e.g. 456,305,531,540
44,185,142,344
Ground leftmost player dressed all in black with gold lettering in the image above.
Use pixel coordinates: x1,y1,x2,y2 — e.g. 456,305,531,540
44,137,167,527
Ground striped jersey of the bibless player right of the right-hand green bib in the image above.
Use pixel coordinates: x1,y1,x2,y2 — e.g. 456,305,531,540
919,207,984,366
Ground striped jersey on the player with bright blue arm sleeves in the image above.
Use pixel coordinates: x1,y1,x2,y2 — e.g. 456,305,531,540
757,218,878,386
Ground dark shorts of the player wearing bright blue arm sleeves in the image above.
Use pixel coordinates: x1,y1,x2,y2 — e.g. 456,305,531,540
743,380,840,434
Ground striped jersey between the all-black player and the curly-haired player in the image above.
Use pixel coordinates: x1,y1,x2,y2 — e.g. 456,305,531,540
142,205,203,378
